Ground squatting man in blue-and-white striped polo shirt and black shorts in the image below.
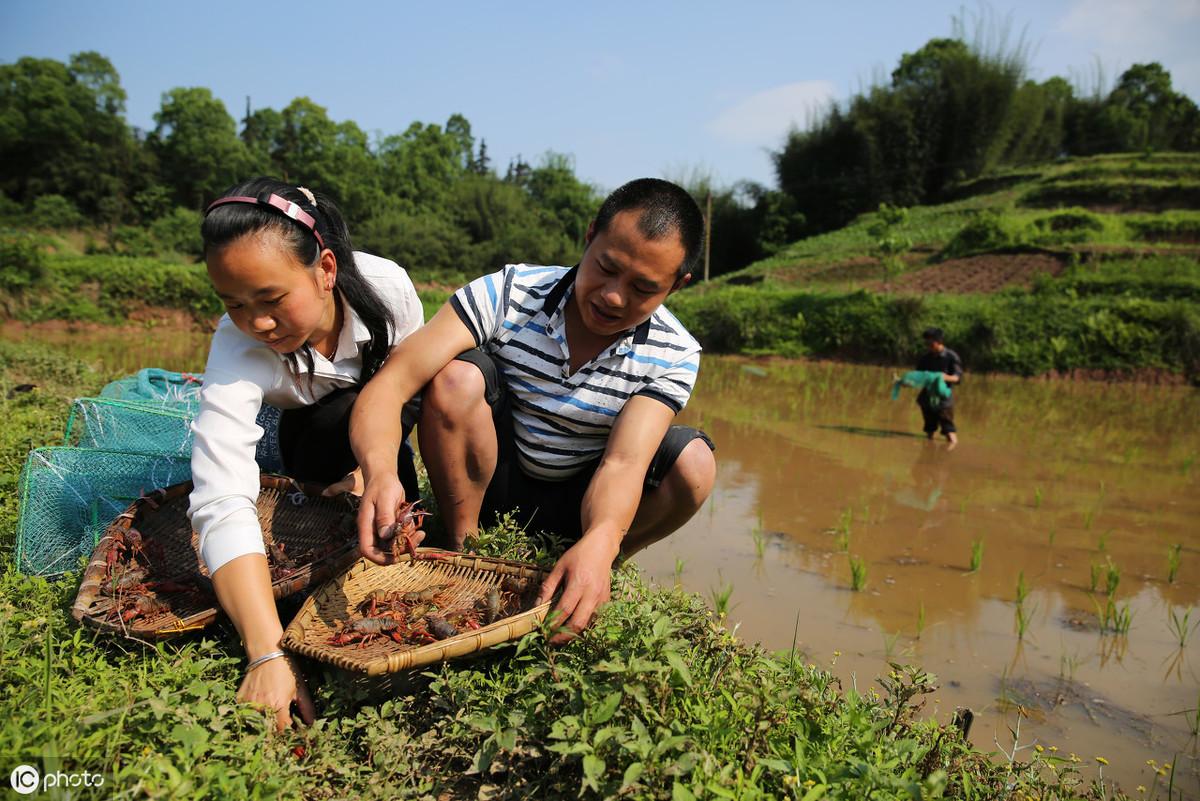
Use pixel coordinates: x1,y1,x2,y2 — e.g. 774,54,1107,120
350,179,715,639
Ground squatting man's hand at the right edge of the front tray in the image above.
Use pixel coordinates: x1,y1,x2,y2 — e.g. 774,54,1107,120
538,531,620,645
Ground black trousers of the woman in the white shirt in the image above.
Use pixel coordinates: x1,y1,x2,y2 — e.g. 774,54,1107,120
280,386,418,498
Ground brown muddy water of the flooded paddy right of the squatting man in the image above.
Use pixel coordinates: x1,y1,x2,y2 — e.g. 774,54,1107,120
637,357,1200,795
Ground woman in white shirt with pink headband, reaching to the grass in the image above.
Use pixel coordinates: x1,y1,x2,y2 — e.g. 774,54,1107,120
188,179,422,727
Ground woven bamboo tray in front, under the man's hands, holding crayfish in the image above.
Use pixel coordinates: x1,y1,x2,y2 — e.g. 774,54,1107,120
283,548,550,676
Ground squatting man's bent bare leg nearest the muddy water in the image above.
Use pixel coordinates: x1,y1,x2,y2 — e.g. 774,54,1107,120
620,439,716,556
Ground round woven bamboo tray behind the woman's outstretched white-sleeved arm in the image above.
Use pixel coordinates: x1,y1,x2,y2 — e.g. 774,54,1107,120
71,476,358,639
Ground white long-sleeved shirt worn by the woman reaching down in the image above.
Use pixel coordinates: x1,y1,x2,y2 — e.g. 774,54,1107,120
187,253,425,576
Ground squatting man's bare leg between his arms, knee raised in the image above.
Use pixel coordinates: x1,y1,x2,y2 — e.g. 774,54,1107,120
416,361,497,550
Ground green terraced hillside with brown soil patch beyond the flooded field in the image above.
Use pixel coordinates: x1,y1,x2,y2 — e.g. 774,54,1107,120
671,153,1200,380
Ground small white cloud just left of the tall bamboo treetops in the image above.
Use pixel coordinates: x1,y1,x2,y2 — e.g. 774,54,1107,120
706,80,836,146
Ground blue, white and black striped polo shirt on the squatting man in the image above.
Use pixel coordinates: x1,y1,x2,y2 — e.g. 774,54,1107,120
450,264,700,481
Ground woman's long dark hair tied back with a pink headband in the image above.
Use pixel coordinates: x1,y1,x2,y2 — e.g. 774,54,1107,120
200,177,397,384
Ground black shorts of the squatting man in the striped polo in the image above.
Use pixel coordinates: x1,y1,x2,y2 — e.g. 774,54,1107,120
457,348,716,541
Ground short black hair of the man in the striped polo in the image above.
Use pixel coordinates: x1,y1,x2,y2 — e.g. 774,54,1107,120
593,177,704,278
